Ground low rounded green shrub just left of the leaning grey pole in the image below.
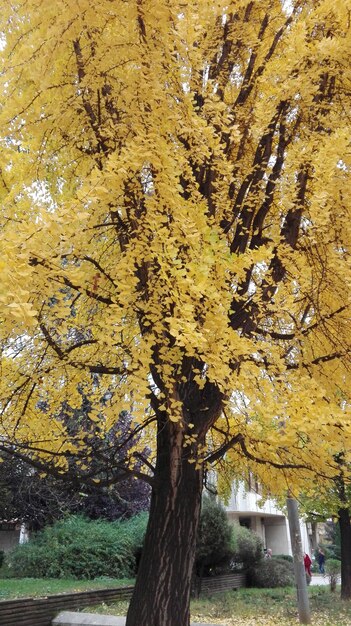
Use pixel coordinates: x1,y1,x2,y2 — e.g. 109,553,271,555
249,559,294,588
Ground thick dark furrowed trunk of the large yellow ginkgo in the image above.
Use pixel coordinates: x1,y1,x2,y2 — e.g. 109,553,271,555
126,414,203,626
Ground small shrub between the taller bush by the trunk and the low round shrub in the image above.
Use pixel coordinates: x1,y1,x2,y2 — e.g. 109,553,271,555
231,524,263,569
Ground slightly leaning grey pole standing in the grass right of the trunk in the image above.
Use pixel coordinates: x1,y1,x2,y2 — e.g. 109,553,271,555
286,498,311,624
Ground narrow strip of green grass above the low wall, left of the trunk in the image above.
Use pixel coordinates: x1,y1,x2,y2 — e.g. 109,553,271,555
0,578,134,601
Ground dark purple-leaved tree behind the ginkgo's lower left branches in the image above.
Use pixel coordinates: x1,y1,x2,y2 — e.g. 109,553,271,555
0,398,150,530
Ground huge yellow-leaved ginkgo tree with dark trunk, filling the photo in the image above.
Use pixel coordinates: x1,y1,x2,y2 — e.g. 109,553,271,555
0,0,351,626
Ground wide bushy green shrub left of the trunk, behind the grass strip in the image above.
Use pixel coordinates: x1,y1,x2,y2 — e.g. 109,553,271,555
7,516,146,579
